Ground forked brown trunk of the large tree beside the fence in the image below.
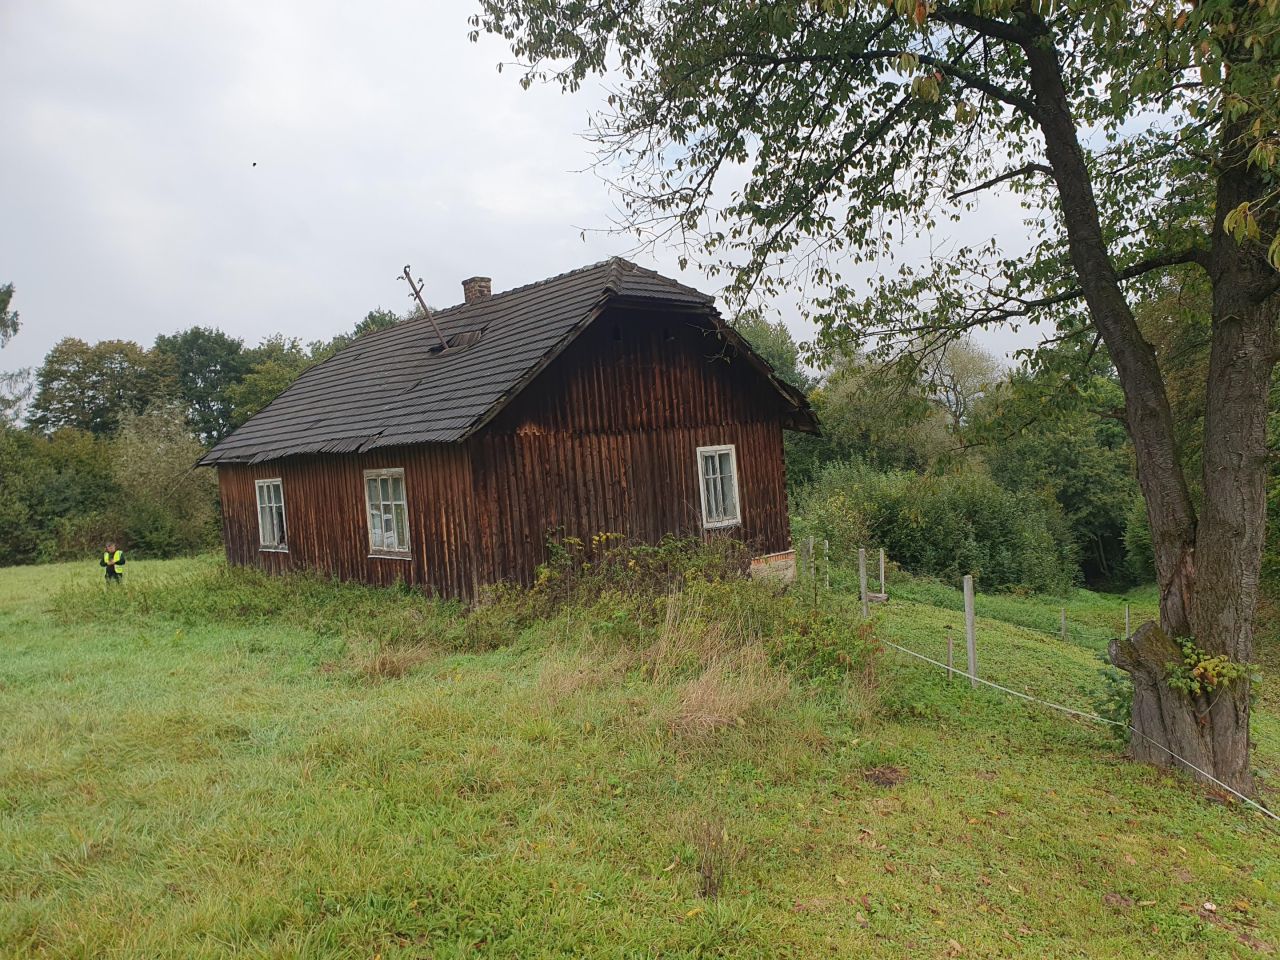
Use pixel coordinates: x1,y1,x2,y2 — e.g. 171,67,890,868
1024,20,1277,794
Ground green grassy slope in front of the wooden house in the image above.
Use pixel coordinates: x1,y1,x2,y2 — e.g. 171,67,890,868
0,561,1280,957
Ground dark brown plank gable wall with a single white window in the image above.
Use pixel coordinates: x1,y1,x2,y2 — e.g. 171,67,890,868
468,310,791,582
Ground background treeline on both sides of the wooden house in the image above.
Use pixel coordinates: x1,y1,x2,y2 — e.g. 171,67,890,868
0,276,1280,601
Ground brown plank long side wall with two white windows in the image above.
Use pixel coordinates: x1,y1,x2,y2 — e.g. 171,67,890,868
218,444,476,596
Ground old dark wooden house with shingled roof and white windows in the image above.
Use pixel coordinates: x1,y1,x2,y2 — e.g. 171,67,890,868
201,259,817,598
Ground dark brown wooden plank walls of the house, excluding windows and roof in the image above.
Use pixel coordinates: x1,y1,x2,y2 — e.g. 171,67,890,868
219,308,791,598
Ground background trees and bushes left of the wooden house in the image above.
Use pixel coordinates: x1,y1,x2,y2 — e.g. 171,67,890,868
0,293,414,564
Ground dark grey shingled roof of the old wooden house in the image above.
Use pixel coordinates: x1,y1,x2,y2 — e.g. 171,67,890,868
200,257,812,465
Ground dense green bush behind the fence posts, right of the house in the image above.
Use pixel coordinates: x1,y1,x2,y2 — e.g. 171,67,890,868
795,463,1075,591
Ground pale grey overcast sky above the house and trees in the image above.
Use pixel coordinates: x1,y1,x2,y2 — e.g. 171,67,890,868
0,0,1016,369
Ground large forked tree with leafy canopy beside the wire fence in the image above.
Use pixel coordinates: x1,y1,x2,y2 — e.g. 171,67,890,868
474,0,1280,791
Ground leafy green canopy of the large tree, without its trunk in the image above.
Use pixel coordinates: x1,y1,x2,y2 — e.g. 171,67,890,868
477,0,1280,353
